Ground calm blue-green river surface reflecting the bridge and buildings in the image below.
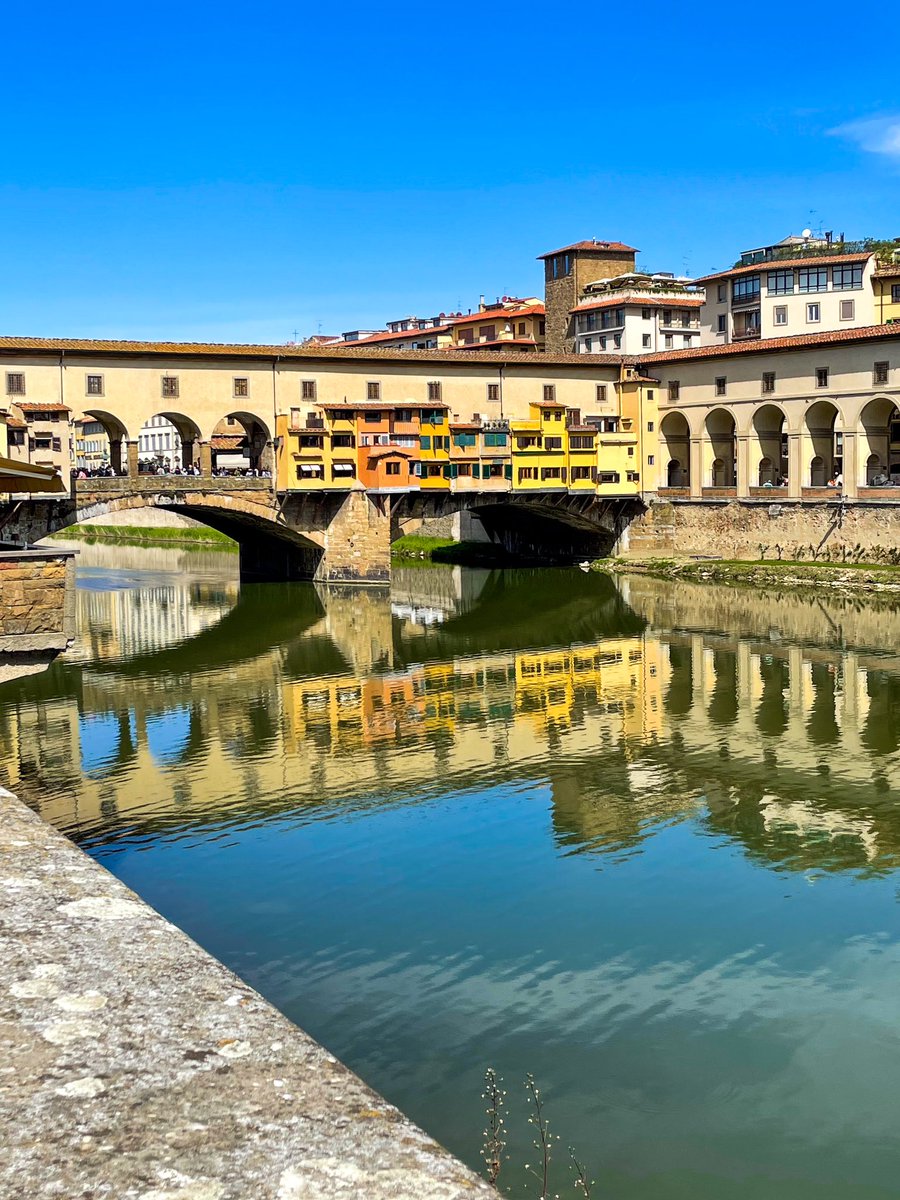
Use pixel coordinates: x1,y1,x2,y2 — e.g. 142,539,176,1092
0,546,900,1200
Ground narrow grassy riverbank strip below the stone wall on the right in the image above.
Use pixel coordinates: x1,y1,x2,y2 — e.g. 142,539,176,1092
590,558,900,594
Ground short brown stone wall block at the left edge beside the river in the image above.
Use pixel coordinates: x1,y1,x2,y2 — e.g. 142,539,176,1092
0,550,74,653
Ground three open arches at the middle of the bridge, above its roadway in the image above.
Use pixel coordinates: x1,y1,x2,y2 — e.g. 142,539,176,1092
84,408,275,474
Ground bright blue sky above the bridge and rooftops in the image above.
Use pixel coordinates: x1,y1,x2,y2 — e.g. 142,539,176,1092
0,0,900,342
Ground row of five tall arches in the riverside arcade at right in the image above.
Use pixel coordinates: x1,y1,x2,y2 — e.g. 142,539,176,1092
660,397,900,488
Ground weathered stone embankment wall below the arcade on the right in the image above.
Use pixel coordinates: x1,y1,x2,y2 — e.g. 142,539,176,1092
619,500,900,560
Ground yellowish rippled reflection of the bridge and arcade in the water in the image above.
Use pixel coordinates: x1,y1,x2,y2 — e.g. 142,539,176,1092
0,561,900,869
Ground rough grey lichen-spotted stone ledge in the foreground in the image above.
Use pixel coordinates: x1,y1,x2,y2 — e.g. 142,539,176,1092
0,790,496,1200
